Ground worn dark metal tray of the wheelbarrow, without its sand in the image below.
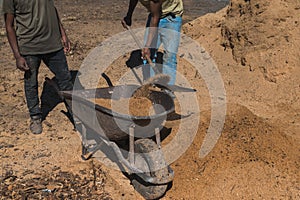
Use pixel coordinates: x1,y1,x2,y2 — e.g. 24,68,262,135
59,85,174,141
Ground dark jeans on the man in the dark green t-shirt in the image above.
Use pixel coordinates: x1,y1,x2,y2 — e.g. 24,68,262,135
23,49,73,118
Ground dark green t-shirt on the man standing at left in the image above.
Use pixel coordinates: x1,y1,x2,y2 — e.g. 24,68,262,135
0,0,62,55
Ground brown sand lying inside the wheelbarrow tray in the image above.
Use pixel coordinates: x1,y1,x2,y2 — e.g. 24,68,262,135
93,96,154,116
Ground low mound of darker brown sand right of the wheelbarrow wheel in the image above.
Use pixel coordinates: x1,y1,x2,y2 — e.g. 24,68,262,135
169,104,300,199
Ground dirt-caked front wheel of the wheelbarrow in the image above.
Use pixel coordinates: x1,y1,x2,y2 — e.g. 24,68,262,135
132,139,168,199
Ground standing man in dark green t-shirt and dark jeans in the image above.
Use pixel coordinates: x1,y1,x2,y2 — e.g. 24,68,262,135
0,0,73,134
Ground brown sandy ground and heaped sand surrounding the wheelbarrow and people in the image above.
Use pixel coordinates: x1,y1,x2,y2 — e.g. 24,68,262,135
0,0,300,199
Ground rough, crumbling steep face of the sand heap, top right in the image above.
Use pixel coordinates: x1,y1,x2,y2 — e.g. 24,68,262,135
222,0,300,82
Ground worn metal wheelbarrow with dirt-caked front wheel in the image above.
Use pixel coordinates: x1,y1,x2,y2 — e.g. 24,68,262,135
59,85,175,199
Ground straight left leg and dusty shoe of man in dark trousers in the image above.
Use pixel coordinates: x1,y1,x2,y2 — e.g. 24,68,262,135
24,56,43,134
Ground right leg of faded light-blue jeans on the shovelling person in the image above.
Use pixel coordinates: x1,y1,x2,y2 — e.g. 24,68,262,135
159,16,182,85
